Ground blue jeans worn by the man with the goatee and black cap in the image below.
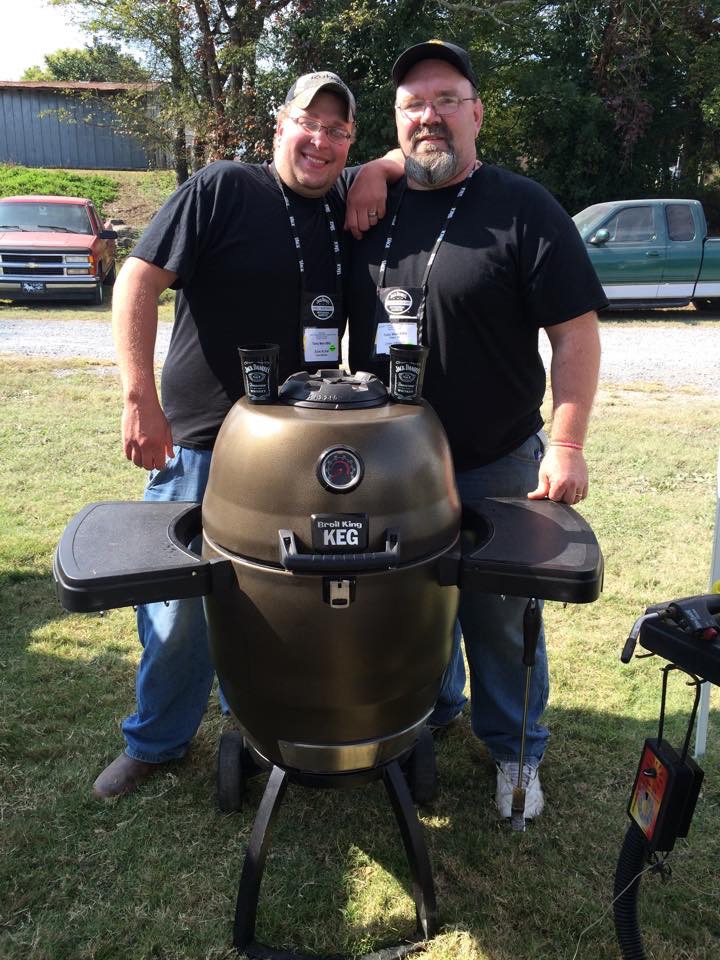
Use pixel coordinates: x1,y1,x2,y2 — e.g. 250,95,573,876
430,435,549,765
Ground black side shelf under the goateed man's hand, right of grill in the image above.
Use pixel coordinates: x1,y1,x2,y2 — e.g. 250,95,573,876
460,497,604,603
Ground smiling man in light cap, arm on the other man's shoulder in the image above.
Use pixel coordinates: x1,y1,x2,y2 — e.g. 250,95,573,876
94,72,401,798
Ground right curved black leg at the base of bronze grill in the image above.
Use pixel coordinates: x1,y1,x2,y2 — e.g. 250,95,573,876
383,760,437,940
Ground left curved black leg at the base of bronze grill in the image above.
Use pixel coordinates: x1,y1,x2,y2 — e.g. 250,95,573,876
233,767,288,950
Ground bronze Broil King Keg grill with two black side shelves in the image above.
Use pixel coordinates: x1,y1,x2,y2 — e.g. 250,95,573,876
54,358,602,957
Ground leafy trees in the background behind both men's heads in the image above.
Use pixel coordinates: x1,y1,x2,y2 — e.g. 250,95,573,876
50,0,720,212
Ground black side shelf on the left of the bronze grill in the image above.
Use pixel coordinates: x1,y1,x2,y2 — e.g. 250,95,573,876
53,501,218,613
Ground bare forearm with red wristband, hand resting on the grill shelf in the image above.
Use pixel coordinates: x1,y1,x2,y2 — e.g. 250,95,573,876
528,310,600,504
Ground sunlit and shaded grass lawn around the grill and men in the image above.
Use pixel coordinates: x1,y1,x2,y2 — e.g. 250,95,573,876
0,356,720,960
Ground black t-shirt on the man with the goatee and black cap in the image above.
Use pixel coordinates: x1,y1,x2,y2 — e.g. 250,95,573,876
346,164,607,470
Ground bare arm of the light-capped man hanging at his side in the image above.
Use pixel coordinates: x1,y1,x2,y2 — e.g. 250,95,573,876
112,256,177,470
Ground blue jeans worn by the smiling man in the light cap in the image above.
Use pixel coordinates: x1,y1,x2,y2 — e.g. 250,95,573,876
122,447,214,763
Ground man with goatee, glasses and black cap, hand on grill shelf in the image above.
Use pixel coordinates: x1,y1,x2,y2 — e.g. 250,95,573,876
349,40,606,818
